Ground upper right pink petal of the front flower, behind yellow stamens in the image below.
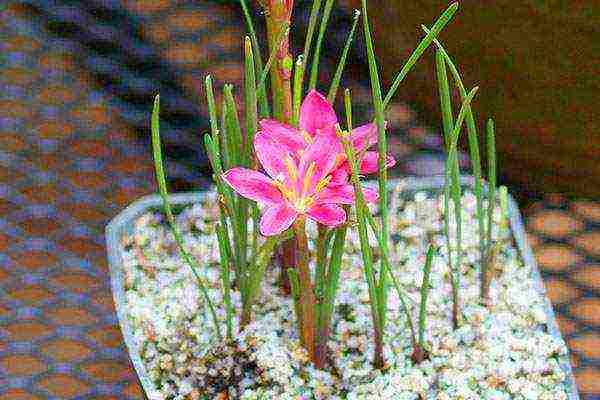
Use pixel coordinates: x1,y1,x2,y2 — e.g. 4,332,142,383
298,136,340,195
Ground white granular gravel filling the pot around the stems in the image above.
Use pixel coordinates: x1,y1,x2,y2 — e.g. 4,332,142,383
117,188,567,400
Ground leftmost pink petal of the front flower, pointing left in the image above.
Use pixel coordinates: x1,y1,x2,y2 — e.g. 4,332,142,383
221,167,283,204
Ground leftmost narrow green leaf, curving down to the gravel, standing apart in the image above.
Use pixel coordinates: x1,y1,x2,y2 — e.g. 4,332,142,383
151,95,223,340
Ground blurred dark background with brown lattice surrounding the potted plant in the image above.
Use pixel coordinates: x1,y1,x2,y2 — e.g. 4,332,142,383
0,0,600,400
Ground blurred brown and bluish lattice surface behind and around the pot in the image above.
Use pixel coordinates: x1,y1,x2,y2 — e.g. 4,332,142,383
0,0,600,400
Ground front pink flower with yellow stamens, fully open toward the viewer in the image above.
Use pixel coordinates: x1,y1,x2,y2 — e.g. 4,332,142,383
222,131,377,236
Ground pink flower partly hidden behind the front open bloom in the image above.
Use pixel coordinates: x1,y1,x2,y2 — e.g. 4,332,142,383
260,90,396,184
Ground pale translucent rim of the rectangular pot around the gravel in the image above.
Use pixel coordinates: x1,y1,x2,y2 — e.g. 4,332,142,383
106,176,579,400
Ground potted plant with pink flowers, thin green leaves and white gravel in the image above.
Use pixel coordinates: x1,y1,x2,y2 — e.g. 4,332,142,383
107,0,577,400
